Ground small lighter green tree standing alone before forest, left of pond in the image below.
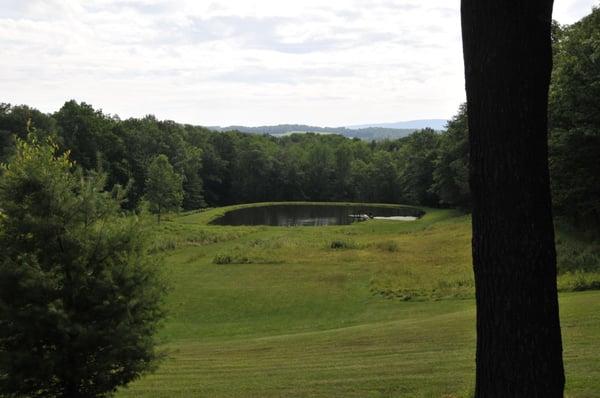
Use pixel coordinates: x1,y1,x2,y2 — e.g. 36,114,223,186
146,155,183,222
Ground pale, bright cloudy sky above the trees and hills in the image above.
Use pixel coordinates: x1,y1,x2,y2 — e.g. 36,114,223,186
0,0,600,126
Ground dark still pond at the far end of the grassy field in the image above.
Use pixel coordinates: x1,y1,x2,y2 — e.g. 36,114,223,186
211,204,424,227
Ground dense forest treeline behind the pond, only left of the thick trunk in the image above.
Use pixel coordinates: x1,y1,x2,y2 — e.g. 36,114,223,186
0,101,468,210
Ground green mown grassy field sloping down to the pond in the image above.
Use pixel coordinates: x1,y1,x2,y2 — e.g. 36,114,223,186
118,204,600,398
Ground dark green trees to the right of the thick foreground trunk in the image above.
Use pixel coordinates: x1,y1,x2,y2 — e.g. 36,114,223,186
550,8,600,231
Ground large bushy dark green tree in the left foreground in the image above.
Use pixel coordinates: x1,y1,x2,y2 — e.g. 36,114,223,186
0,140,164,397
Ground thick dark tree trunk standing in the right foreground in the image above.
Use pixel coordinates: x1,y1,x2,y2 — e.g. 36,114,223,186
461,0,564,398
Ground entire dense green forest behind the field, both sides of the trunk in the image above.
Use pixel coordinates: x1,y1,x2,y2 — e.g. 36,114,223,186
0,9,600,232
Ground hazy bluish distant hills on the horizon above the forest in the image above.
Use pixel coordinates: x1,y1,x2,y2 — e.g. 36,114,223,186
208,121,445,141
